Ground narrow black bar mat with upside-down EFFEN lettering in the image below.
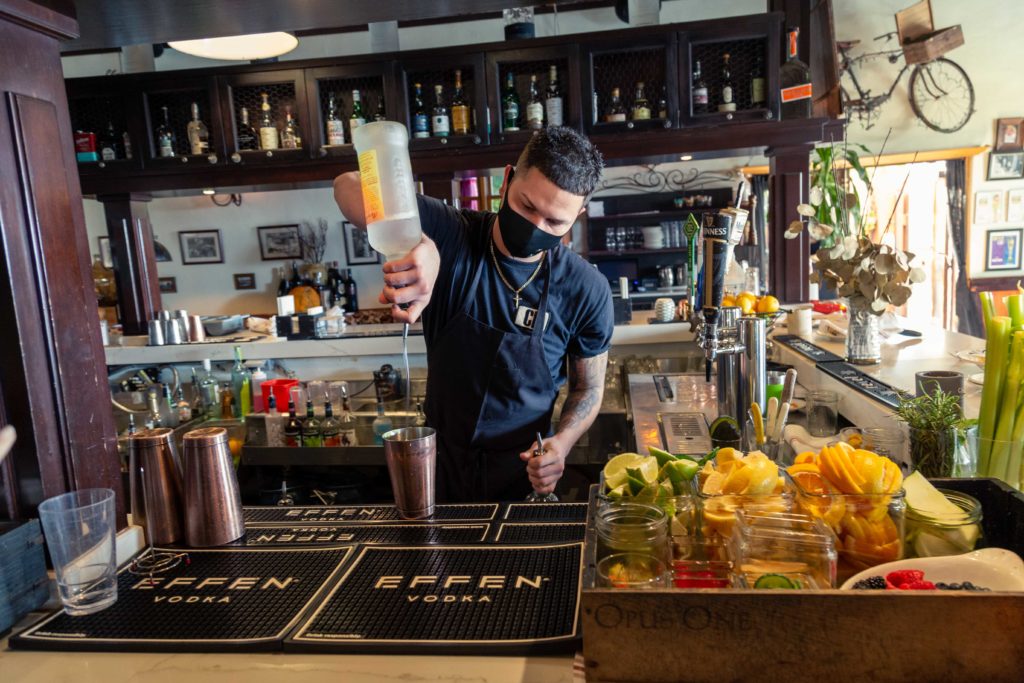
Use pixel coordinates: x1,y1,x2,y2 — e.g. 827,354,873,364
239,524,491,546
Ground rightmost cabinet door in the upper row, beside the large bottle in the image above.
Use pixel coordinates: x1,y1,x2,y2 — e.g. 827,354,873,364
679,12,782,126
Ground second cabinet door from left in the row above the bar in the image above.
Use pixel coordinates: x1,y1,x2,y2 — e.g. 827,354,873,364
139,75,226,169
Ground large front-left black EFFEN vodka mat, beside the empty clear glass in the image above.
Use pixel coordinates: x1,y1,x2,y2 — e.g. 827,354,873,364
10,547,352,652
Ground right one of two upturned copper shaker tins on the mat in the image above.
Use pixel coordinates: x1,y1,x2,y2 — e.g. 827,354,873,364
183,427,246,548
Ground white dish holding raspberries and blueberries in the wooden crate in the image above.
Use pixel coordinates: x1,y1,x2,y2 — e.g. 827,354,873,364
842,548,1024,592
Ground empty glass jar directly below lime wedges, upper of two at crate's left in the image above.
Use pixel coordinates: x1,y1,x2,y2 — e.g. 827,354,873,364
595,503,672,566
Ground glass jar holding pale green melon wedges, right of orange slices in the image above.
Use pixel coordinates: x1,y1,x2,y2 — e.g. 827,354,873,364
904,488,982,557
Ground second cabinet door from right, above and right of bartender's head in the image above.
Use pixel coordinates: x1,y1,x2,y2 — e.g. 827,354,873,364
583,34,679,134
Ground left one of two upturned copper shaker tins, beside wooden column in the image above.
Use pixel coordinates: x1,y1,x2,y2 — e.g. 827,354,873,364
128,427,183,545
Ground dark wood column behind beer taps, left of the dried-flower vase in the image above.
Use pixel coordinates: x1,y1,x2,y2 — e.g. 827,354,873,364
767,144,814,303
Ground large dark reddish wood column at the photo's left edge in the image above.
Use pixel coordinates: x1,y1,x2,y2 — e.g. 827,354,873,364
0,0,124,525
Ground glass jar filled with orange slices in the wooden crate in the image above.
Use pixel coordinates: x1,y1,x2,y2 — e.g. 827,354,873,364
793,480,906,584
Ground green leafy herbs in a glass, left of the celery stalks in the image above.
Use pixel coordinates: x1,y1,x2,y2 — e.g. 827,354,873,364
896,387,964,478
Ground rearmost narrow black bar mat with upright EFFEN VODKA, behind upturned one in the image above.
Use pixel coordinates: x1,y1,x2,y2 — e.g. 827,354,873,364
239,503,498,525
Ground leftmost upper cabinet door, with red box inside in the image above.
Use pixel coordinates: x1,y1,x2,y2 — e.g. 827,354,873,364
67,77,145,176
